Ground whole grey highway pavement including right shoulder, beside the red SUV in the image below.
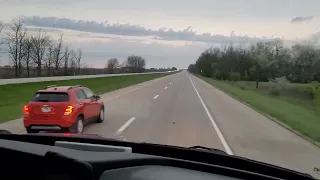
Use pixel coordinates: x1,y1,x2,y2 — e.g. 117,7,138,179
85,71,320,177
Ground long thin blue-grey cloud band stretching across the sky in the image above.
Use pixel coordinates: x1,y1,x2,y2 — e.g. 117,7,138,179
23,16,267,43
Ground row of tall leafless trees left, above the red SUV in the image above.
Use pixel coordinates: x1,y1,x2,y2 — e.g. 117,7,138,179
0,18,83,77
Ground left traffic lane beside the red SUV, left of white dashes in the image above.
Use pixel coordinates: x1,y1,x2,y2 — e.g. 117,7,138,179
84,74,177,139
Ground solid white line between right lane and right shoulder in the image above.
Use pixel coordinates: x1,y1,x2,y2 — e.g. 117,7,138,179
187,75,233,155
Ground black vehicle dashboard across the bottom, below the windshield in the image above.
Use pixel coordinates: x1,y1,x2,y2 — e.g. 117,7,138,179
0,136,312,180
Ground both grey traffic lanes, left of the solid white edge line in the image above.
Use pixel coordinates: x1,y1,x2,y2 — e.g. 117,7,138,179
85,72,224,150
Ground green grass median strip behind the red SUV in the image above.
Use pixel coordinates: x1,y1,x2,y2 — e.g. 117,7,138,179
0,73,174,123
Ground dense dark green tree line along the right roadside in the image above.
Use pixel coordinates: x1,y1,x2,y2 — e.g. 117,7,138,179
188,39,320,88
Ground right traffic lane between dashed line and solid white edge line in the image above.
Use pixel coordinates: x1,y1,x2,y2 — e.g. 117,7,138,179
117,73,223,149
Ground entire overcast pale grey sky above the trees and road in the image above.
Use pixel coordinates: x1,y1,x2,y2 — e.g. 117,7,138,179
0,0,320,68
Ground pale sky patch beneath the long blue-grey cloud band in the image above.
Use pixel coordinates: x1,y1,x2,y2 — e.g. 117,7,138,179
0,27,206,68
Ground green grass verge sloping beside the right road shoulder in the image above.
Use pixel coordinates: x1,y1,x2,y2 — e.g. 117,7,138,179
198,76,320,143
